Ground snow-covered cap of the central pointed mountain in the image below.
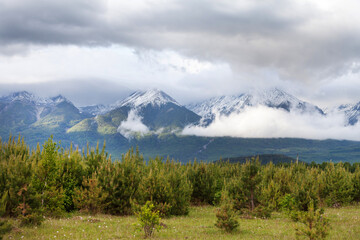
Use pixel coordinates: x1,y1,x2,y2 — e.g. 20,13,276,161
116,89,180,108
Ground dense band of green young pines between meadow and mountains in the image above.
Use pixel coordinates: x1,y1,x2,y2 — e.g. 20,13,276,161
0,136,360,224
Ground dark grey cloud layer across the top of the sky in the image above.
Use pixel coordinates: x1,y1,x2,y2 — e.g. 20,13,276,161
0,0,360,81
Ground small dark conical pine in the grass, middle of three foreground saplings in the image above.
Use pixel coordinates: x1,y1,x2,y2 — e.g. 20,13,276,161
215,191,239,233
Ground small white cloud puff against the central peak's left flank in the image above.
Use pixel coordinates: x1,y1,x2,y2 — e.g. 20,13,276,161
118,110,149,138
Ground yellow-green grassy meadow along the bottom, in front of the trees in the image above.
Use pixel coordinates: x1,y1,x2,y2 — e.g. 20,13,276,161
4,206,360,240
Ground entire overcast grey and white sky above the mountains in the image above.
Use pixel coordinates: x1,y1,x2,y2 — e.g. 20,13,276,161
0,0,360,107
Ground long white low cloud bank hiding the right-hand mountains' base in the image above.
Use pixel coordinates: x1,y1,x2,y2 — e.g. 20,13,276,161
183,106,360,141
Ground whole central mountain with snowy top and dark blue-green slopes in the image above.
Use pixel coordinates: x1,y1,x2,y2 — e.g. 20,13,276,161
69,89,200,134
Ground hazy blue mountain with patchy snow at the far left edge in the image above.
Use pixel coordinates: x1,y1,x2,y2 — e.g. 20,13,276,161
0,91,90,138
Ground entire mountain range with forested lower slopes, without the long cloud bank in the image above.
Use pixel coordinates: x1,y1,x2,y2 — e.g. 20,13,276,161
0,88,360,161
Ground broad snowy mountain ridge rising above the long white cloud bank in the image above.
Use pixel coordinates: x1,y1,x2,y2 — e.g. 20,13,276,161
187,88,324,125
